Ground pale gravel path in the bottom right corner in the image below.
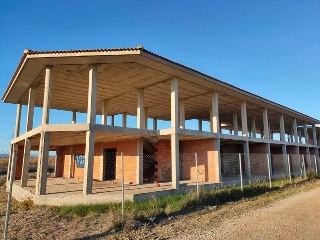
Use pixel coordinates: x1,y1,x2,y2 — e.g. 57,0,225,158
177,188,320,240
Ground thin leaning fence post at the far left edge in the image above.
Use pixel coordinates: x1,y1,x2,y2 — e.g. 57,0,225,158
3,144,18,240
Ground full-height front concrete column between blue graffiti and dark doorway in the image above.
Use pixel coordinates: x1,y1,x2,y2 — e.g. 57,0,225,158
83,64,98,195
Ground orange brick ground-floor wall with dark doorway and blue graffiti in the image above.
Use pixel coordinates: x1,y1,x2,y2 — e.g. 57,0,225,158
57,140,137,182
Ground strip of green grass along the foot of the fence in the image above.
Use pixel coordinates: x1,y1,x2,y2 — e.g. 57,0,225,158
57,175,303,220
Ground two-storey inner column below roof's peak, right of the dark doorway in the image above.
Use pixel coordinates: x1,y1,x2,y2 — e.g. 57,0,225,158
136,88,146,184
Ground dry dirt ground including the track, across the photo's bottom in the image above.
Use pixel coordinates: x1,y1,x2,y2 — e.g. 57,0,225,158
0,180,320,239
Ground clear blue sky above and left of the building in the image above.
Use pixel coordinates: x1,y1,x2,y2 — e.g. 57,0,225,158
0,0,320,151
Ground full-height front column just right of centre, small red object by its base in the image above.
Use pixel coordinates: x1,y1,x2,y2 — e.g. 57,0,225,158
171,78,180,189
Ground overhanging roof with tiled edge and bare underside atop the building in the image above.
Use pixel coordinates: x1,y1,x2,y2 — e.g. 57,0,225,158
2,46,320,131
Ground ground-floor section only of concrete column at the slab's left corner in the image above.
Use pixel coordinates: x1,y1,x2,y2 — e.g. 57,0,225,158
36,132,50,195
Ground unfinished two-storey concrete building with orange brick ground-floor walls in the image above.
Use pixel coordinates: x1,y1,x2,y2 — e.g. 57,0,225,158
2,46,320,204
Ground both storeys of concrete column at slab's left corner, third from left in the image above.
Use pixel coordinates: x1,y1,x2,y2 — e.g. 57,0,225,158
35,66,51,195
